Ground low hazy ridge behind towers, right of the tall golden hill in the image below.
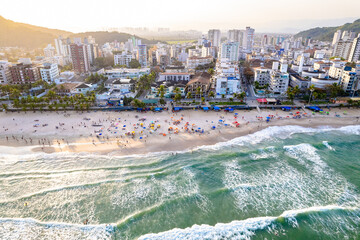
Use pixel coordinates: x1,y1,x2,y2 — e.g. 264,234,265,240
69,31,159,45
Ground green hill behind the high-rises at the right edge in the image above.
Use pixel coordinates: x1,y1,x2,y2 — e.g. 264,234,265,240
295,19,360,41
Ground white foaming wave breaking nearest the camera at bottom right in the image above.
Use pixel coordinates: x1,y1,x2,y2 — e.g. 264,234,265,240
139,205,359,240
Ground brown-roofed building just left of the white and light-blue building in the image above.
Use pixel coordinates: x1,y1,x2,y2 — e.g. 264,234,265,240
186,72,211,97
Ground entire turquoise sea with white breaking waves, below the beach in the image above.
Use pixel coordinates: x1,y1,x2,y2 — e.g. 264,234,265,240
0,126,360,239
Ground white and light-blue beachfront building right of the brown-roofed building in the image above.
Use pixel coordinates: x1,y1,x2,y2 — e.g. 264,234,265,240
214,59,241,97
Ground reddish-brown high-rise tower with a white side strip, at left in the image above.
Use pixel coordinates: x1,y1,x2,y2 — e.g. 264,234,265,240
70,44,90,74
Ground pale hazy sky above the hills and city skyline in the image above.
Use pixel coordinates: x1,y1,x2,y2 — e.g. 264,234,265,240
0,0,360,33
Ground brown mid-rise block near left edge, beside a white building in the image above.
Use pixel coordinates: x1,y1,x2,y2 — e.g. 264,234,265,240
10,63,41,84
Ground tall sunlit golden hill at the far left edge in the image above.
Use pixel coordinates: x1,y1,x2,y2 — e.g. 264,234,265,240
0,16,71,48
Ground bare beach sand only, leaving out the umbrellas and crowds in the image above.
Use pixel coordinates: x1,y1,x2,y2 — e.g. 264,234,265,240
0,109,360,156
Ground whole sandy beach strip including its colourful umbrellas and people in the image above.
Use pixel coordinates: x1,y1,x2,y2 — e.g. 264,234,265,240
0,108,360,155
